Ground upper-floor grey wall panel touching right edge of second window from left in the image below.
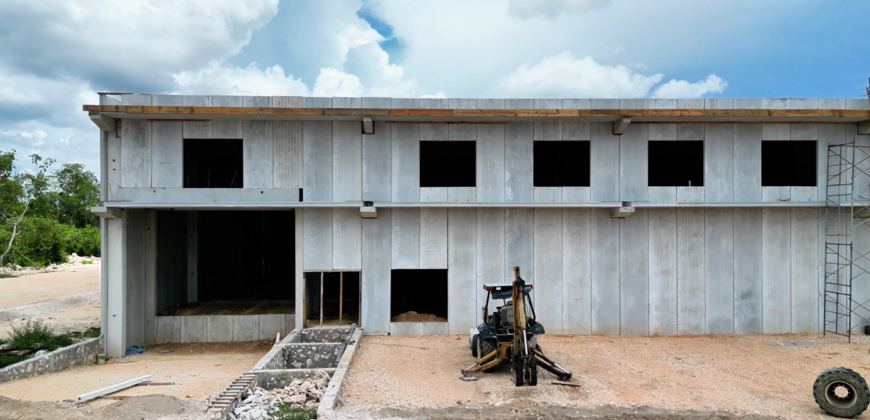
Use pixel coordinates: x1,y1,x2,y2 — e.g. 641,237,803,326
475,124,505,202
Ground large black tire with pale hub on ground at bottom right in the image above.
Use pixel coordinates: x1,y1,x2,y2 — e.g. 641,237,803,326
813,367,870,419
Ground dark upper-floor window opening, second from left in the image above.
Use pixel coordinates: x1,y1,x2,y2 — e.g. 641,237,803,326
420,141,477,187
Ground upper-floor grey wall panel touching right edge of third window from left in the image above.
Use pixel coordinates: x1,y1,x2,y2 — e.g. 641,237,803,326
589,123,620,202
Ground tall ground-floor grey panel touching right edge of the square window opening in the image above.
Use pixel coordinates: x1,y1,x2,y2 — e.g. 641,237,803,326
447,208,479,334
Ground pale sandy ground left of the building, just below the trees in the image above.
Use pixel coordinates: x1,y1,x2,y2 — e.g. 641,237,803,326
0,262,100,308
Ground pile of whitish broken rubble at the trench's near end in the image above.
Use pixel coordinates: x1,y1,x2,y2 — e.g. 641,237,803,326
229,371,329,420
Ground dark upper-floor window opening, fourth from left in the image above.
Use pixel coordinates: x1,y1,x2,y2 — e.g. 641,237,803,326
649,141,704,187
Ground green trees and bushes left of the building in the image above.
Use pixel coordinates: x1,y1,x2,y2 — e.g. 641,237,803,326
0,150,100,267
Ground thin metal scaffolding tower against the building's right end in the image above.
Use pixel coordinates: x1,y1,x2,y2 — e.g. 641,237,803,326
824,139,870,341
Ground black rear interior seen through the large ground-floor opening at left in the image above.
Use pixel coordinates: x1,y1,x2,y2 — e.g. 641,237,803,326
197,210,296,302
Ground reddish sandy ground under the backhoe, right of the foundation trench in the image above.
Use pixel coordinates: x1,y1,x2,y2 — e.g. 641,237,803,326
339,335,870,419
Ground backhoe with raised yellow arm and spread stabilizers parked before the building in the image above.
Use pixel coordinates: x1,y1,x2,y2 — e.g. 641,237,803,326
462,267,571,386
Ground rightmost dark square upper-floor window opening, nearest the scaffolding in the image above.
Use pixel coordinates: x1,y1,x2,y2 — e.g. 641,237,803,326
761,140,818,187
